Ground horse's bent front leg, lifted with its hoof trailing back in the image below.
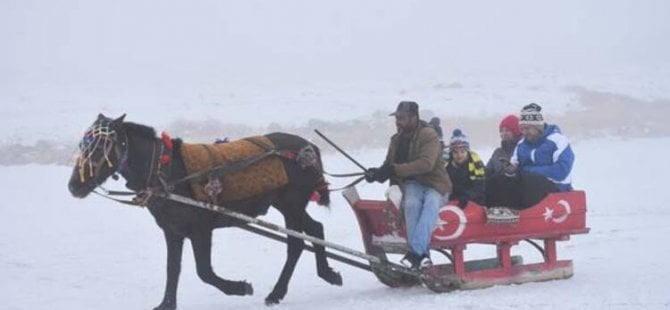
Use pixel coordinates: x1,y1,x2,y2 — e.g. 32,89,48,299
191,229,254,295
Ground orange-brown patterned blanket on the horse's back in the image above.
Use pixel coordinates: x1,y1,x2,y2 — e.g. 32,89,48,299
181,136,288,202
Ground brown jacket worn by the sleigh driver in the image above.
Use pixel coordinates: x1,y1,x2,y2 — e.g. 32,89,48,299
386,121,451,195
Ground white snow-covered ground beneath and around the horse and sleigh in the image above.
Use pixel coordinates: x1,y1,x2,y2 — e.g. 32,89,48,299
0,138,670,310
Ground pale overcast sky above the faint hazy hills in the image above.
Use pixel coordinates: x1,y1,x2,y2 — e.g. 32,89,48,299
0,0,670,92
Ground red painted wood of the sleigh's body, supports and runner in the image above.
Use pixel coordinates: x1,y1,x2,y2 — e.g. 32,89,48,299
352,191,589,288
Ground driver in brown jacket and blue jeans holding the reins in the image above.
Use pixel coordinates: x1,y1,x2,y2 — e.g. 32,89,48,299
365,101,451,269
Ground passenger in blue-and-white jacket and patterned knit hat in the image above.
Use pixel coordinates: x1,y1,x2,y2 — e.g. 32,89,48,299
486,103,575,209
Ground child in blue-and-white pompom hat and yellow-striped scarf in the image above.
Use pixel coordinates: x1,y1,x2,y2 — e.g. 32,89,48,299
447,129,485,208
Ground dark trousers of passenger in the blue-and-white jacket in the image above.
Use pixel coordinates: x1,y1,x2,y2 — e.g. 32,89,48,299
486,172,559,210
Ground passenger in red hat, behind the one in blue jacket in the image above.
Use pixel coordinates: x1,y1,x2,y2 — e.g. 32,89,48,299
486,114,521,178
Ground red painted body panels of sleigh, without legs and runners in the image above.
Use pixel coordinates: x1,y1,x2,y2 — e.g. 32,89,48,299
353,191,588,248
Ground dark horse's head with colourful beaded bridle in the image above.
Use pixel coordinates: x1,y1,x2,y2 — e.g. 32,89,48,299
68,114,128,198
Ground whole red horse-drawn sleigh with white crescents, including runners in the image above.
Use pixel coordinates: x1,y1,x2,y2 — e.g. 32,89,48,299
343,187,589,292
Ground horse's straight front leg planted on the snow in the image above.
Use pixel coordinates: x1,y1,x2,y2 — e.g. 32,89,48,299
154,229,184,310
